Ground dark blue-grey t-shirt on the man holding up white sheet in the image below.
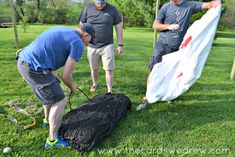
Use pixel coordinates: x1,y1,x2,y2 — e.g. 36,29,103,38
156,0,202,49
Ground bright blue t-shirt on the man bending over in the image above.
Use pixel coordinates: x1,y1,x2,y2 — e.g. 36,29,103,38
19,26,84,71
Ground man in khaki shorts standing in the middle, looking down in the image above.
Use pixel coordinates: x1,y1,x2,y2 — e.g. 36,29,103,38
79,0,123,93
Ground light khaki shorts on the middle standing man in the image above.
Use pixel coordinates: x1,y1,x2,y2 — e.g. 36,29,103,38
87,44,115,70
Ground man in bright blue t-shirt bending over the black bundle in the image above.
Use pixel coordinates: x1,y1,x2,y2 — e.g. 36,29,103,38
17,23,95,149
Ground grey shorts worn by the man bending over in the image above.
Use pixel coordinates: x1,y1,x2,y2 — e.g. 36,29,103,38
17,59,65,105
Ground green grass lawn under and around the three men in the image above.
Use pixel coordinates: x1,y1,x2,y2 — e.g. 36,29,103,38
0,26,235,157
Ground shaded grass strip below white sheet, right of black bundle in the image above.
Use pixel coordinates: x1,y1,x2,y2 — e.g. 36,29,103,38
92,87,235,149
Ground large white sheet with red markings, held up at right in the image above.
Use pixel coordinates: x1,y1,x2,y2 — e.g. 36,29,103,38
146,5,221,103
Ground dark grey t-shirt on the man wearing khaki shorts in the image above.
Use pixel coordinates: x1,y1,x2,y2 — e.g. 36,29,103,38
78,3,121,48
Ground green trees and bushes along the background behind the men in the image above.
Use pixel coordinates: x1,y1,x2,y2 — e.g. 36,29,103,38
0,0,235,28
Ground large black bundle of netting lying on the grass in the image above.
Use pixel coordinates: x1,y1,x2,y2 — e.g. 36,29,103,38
59,94,132,151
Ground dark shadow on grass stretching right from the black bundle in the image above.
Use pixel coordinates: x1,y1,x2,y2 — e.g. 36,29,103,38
95,100,235,152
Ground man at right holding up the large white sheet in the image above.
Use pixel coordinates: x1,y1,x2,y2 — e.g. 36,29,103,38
137,0,220,109
